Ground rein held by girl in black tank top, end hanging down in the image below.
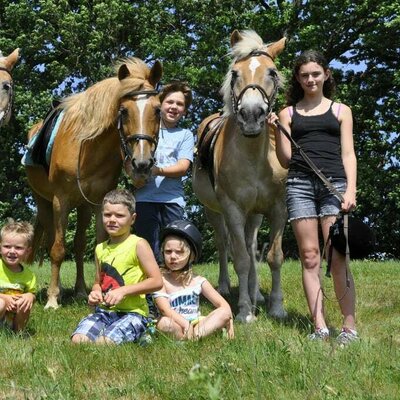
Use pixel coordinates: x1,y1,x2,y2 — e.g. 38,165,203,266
275,121,350,302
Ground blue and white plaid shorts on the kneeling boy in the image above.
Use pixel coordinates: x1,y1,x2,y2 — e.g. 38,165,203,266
71,307,148,344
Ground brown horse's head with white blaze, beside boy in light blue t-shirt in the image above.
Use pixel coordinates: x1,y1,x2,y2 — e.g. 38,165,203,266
118,61,162,182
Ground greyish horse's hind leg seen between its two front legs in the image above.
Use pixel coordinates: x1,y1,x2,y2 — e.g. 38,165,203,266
245,214,265,306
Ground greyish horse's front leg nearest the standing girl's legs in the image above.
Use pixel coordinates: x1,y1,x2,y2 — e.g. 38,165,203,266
267,204,287,319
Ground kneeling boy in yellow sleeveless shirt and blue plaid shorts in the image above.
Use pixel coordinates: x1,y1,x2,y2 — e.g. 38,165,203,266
72,189,162,344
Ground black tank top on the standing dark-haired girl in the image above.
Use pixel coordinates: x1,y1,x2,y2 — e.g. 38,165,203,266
288,102,346,178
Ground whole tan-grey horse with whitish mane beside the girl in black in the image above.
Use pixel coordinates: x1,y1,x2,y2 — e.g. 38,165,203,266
193,30,286,322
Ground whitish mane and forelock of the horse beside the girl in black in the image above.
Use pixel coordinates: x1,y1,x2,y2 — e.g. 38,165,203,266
220,30,284,117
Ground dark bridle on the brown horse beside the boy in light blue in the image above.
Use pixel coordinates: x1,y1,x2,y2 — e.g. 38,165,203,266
117,90,158,164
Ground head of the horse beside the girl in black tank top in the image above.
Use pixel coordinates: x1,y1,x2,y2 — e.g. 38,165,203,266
222,30,286,137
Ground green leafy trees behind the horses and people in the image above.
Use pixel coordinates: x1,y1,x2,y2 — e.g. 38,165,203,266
0,0,400,259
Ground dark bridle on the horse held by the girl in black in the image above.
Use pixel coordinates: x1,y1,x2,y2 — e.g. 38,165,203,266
231,50,279,116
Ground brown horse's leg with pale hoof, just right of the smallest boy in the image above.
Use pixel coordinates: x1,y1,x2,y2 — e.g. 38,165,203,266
44,196,69,309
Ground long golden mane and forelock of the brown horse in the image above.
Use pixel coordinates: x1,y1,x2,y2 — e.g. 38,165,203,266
60,57,150,141
